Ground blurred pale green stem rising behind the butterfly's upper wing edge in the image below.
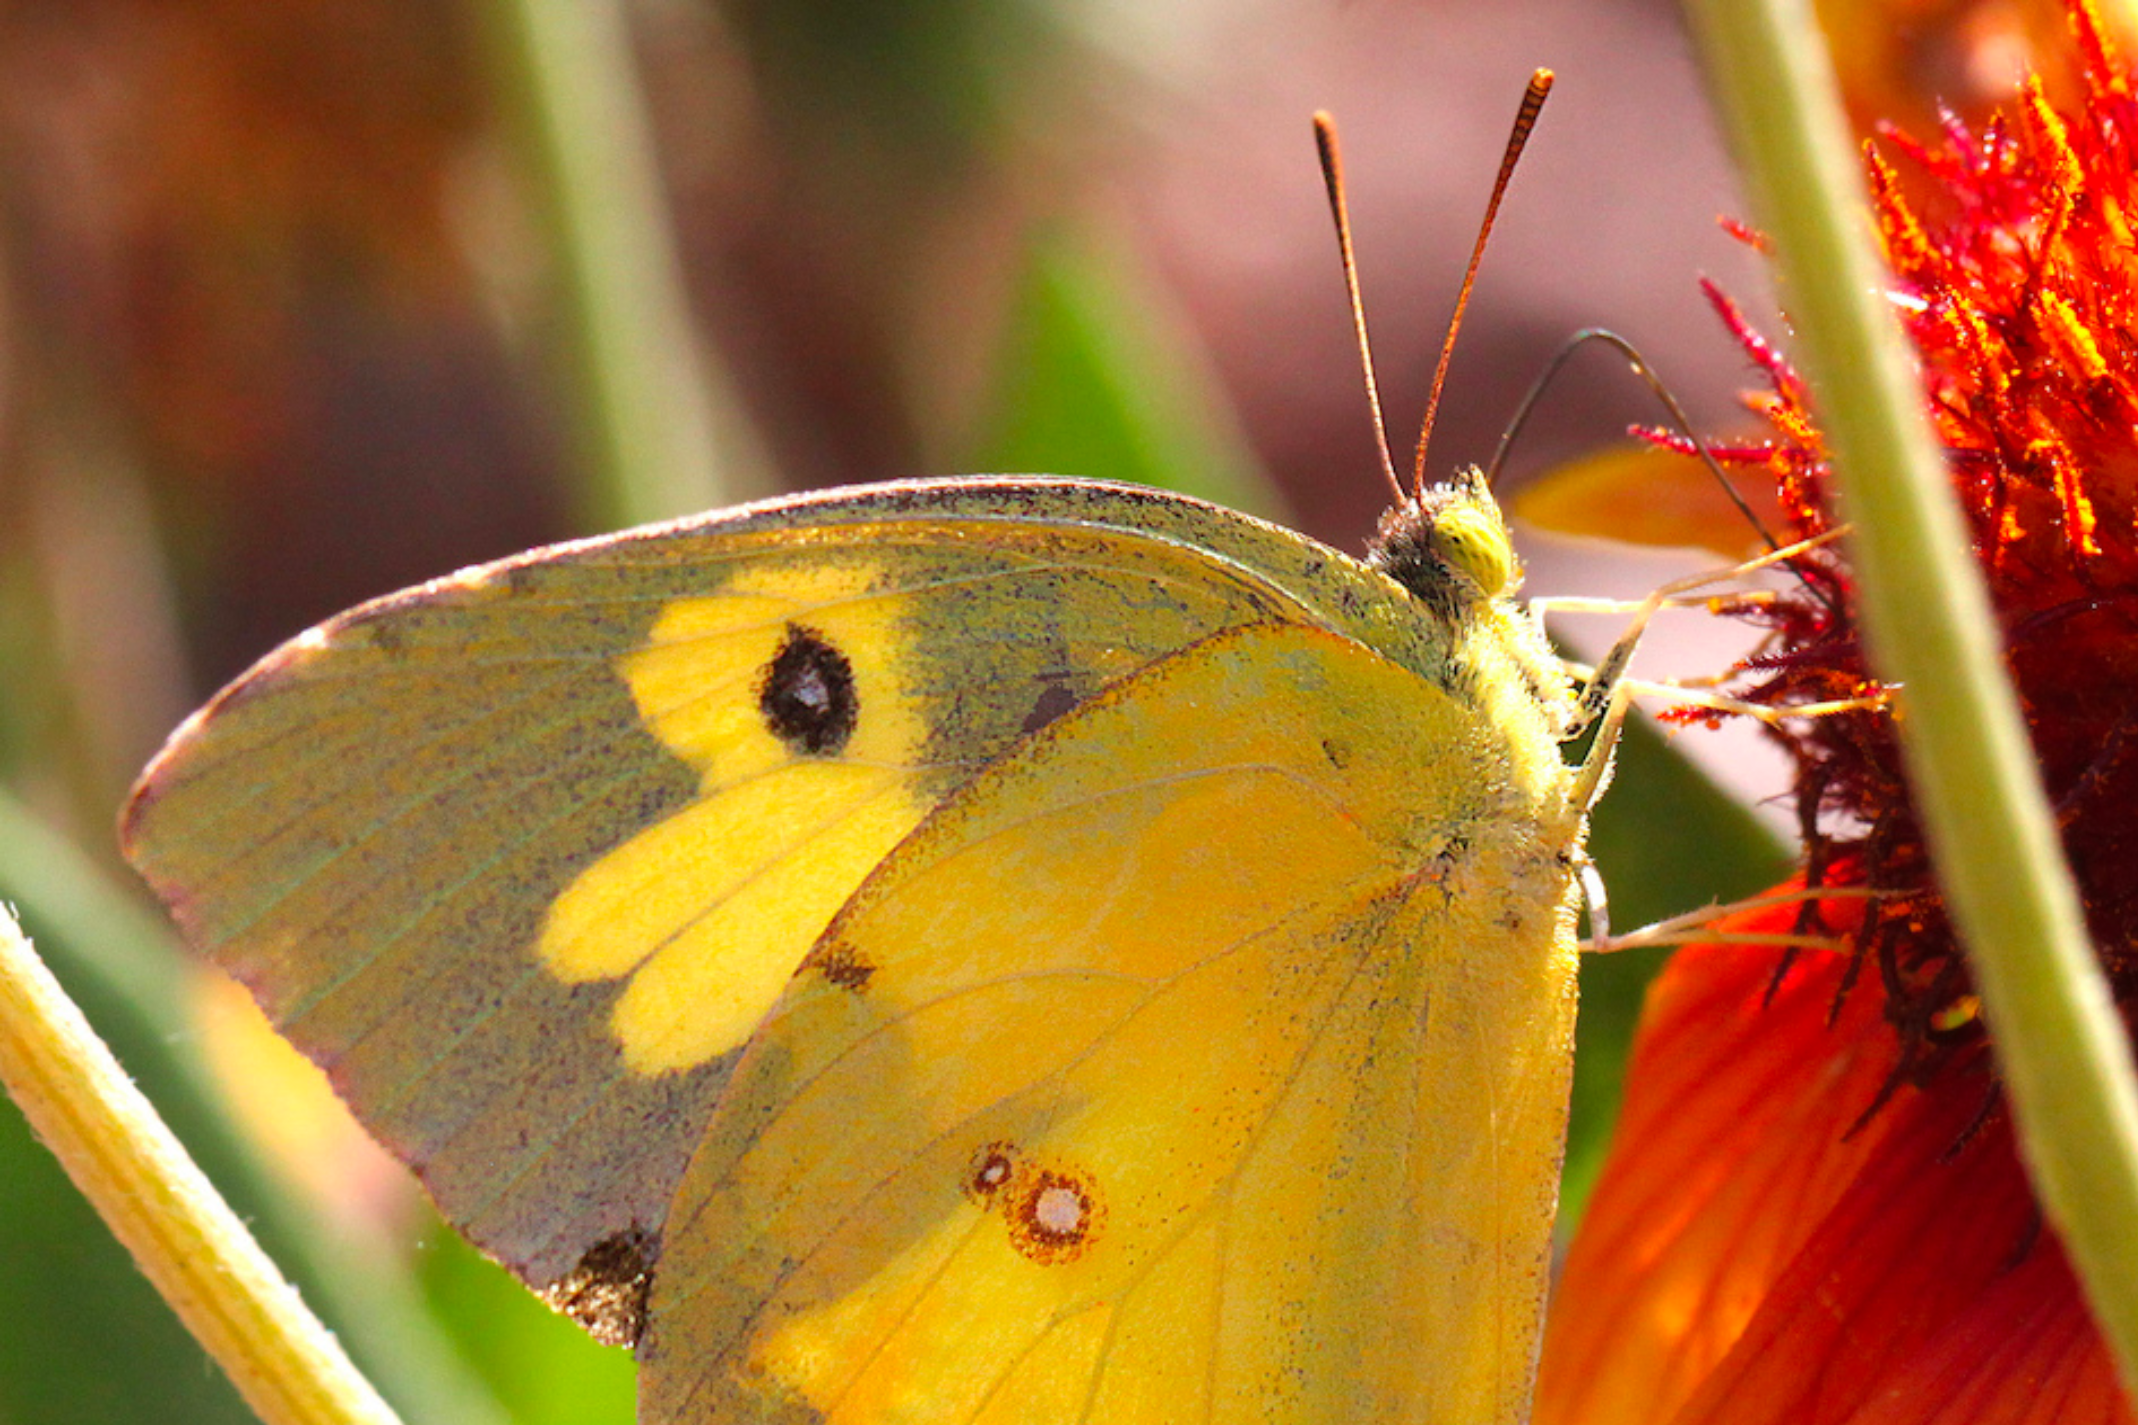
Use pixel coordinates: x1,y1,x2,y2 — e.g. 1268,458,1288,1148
490,0,774,530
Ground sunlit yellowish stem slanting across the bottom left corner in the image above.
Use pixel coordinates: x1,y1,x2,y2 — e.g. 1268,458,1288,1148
0,910,396,1425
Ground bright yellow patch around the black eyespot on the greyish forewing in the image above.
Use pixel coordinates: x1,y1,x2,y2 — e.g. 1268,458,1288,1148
539,560,928,1075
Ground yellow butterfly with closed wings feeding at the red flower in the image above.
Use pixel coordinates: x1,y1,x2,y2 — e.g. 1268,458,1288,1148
124,75,1610,1425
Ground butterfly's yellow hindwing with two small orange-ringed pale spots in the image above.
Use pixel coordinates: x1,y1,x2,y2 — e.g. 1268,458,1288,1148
641,622,1578,1423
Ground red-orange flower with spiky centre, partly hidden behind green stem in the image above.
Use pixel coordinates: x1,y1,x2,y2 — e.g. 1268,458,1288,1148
1537,0,2138,1425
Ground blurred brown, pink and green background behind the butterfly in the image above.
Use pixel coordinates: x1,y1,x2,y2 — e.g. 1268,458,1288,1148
0,0,2061,1425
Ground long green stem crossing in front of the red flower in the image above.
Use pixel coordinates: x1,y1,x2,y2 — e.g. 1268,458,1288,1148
1687,0,2138,1395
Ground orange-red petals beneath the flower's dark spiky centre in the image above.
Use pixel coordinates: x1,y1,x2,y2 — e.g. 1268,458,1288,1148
1537,914,2138,1425
